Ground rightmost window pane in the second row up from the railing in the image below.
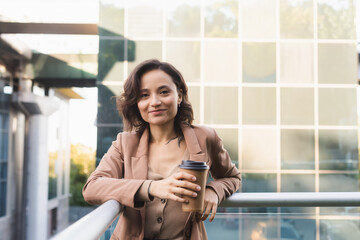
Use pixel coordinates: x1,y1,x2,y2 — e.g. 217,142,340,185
319,130,359,170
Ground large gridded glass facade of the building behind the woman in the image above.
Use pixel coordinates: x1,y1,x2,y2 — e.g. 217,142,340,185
97,0,360,239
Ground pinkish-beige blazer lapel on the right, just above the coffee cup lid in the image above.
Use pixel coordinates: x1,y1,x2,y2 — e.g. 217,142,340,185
181,125,206,162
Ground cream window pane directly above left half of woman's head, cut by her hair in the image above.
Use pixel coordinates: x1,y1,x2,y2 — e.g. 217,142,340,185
128,41,162,74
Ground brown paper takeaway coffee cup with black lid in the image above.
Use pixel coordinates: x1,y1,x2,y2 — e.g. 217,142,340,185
179,160,209,213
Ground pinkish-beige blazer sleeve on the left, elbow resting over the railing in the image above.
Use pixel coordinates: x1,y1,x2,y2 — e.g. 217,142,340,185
82,133,145,208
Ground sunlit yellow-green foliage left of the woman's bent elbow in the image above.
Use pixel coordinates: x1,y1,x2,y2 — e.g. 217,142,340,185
70,144,95,206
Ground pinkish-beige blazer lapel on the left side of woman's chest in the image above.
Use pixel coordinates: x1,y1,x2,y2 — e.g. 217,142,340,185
131,129,149,179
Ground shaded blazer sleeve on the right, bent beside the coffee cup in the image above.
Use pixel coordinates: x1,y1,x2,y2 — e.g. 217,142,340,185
206,129,241,204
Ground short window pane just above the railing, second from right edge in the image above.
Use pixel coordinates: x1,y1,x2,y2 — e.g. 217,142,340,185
281,174,315,192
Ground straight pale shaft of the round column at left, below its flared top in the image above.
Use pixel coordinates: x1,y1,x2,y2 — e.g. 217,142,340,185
25,114,49,240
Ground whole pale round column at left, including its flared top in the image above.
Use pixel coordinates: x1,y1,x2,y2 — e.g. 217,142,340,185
12,84,59,240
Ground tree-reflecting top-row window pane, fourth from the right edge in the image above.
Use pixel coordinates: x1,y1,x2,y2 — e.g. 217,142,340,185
205,0,238,37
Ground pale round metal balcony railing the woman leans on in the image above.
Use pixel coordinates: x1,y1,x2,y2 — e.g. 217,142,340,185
51,192,360,240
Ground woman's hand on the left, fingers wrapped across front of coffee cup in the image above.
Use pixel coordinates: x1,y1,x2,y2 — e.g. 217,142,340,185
149,172,200,203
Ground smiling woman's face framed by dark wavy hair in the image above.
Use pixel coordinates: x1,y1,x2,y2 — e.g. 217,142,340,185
137,69,182,126
